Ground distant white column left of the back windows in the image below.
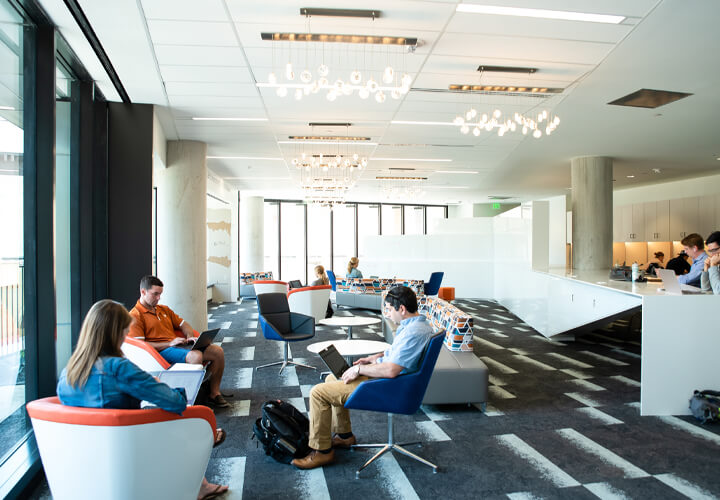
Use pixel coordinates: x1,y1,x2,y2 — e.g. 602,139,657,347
239,194,264,279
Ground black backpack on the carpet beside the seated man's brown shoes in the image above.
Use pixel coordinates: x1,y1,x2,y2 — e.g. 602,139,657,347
253,399,310,464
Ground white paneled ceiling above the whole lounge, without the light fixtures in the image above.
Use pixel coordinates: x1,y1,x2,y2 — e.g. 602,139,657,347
43,0,720,203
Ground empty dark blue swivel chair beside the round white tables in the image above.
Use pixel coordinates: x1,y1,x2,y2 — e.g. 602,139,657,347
255,293,315,373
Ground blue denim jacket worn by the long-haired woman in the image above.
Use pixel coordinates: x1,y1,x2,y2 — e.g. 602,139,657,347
57,356,187,415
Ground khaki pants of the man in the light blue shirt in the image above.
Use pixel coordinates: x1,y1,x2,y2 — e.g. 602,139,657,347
308,373,368,450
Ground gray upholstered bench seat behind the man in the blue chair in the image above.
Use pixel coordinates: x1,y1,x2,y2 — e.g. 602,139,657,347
383,318,488,411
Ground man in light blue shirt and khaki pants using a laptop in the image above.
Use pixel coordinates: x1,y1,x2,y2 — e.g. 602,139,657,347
292,286,433,469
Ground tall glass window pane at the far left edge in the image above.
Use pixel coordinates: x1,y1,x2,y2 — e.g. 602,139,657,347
0,0,29,457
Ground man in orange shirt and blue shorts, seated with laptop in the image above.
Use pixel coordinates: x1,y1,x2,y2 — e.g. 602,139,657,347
128,276,230,408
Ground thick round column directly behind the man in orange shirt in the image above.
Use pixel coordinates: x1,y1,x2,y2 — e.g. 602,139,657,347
157,141,207,331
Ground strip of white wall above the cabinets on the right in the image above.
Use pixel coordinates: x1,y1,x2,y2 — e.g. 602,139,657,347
613,175,720,206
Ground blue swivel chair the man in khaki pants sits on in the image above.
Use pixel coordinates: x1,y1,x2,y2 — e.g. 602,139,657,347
345,331,445,478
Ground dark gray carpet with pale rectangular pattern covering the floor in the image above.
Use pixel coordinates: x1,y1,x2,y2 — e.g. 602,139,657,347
28,300,720,499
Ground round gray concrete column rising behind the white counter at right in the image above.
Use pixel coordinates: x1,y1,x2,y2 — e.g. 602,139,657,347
570,156,613,270
